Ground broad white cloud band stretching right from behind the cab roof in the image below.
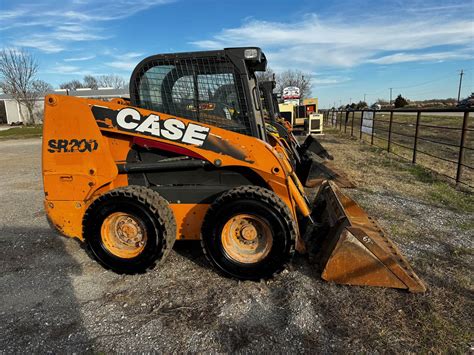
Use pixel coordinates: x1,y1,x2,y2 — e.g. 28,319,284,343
192,14,474,71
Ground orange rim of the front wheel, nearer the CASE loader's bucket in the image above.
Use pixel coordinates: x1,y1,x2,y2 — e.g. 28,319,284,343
221,214,273,264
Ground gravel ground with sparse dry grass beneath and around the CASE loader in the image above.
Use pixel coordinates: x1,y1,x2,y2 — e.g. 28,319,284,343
0,136,473,353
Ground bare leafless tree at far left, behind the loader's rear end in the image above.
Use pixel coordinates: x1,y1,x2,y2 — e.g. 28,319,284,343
0,49,38,124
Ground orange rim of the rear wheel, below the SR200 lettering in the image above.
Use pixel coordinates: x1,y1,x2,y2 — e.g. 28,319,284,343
100,212,147,259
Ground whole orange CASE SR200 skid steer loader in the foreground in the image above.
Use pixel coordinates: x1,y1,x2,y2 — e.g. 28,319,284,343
42,47,425,292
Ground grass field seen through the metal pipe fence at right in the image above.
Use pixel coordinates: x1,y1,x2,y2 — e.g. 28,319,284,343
328,111,474,187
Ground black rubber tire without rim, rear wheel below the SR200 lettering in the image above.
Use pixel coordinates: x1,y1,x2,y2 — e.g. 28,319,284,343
82,186,176,274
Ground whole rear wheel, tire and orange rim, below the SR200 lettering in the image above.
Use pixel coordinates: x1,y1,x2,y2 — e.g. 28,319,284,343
83,186,176,274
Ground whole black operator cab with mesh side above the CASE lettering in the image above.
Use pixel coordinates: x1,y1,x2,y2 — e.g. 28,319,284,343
130,47,267,141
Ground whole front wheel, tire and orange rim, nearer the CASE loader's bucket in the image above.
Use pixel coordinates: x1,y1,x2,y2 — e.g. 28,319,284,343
201,186,296,280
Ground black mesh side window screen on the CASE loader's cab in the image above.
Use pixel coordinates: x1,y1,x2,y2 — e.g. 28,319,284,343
135,57,251,135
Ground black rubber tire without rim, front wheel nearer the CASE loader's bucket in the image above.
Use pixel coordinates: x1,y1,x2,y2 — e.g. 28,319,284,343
201,186,296,280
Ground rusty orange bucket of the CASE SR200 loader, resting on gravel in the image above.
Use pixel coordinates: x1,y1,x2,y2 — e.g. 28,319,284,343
312,181,426,292
